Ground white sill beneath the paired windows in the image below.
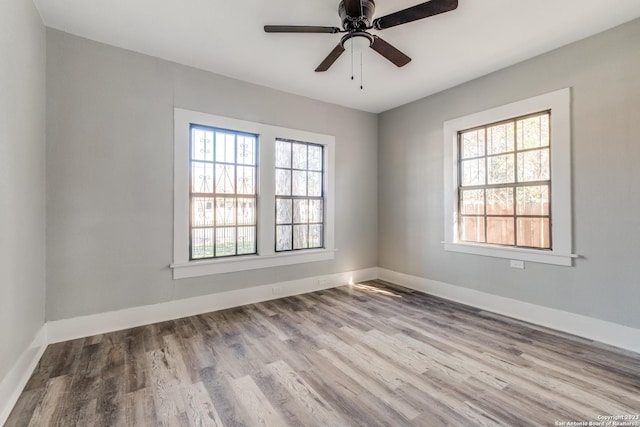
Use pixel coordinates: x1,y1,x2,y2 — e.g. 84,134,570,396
169,249,336,280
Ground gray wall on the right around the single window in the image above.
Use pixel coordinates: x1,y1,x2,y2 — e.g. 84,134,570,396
378,20,640,328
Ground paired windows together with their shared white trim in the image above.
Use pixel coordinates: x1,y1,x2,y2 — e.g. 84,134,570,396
171,108,335,279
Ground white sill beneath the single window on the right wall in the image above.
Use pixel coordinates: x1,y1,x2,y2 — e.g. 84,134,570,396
443,242,578,267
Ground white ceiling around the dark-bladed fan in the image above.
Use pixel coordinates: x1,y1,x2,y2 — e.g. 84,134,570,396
34,0,640,113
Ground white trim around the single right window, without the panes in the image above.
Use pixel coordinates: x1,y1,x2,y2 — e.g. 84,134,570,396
443,88,576,266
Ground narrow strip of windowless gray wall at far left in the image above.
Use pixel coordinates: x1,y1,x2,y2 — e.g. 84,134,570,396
0,0,45,381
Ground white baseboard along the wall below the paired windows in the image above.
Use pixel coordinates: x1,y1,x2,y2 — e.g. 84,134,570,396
47,267,378,343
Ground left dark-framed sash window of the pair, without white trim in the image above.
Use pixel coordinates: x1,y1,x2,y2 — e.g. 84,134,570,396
189,124,258,260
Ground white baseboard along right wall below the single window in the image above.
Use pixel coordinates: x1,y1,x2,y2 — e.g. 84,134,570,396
378,268,640,353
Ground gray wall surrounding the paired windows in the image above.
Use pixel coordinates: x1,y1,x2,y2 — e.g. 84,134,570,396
46,29,377,320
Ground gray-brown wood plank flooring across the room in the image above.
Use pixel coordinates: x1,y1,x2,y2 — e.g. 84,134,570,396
6,281,640,427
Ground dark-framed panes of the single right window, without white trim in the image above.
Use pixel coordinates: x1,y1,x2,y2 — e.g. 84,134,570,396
457,111,552,249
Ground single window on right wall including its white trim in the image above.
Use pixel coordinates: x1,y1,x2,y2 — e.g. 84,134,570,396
444,89,575,266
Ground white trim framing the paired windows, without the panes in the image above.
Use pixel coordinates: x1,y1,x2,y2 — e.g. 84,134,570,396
170,108,336,279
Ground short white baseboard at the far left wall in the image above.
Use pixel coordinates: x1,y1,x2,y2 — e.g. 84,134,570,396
0,325,47,426
